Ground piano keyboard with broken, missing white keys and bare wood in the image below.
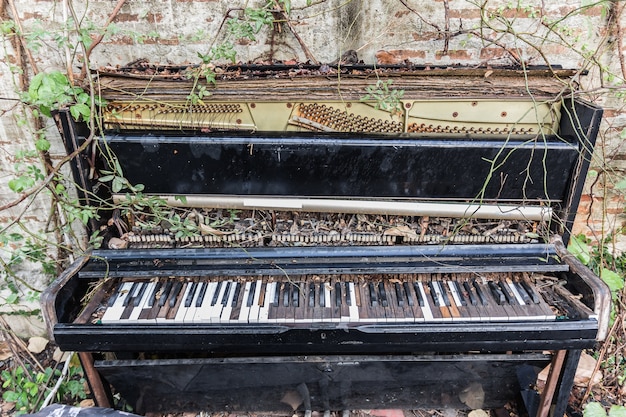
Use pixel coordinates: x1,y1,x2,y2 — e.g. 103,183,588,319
93,274,567,325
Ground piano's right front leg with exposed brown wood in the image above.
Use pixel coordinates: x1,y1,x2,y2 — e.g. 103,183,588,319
536,350,581,417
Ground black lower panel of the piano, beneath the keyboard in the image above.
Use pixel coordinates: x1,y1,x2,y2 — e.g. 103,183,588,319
96,354,549,413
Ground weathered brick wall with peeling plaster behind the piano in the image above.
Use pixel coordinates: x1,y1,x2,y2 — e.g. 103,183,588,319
0,0,626,336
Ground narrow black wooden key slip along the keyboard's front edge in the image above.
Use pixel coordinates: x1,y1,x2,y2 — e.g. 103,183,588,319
54,320,598,355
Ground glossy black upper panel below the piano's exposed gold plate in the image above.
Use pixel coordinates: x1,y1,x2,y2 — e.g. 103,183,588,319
106,134,579,201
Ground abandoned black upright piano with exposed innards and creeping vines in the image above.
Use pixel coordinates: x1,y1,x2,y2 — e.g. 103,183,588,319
43,65,610,416
